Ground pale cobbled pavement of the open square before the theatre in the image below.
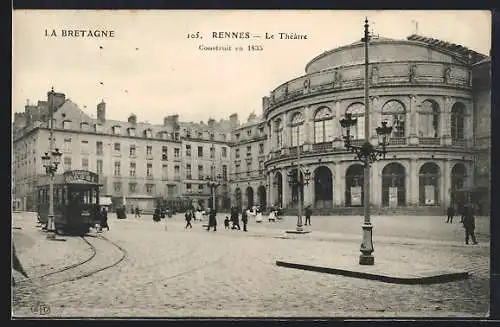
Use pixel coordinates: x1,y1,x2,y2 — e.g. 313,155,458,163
13,215,489,317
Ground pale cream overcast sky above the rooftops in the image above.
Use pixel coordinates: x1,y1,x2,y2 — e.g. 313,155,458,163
12,10,491,123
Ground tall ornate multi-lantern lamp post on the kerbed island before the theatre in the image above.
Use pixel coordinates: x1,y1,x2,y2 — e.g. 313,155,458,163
340,19,392,265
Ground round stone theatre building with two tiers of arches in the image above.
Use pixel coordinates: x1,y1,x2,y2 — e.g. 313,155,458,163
263,35,491,214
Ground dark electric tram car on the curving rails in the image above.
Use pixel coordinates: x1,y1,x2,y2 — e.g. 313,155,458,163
37,170,102,235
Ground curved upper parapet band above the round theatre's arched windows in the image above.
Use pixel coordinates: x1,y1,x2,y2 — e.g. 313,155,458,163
263,61,472,115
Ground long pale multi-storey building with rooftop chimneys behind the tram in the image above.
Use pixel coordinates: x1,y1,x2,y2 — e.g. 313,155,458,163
12,92,237,210
